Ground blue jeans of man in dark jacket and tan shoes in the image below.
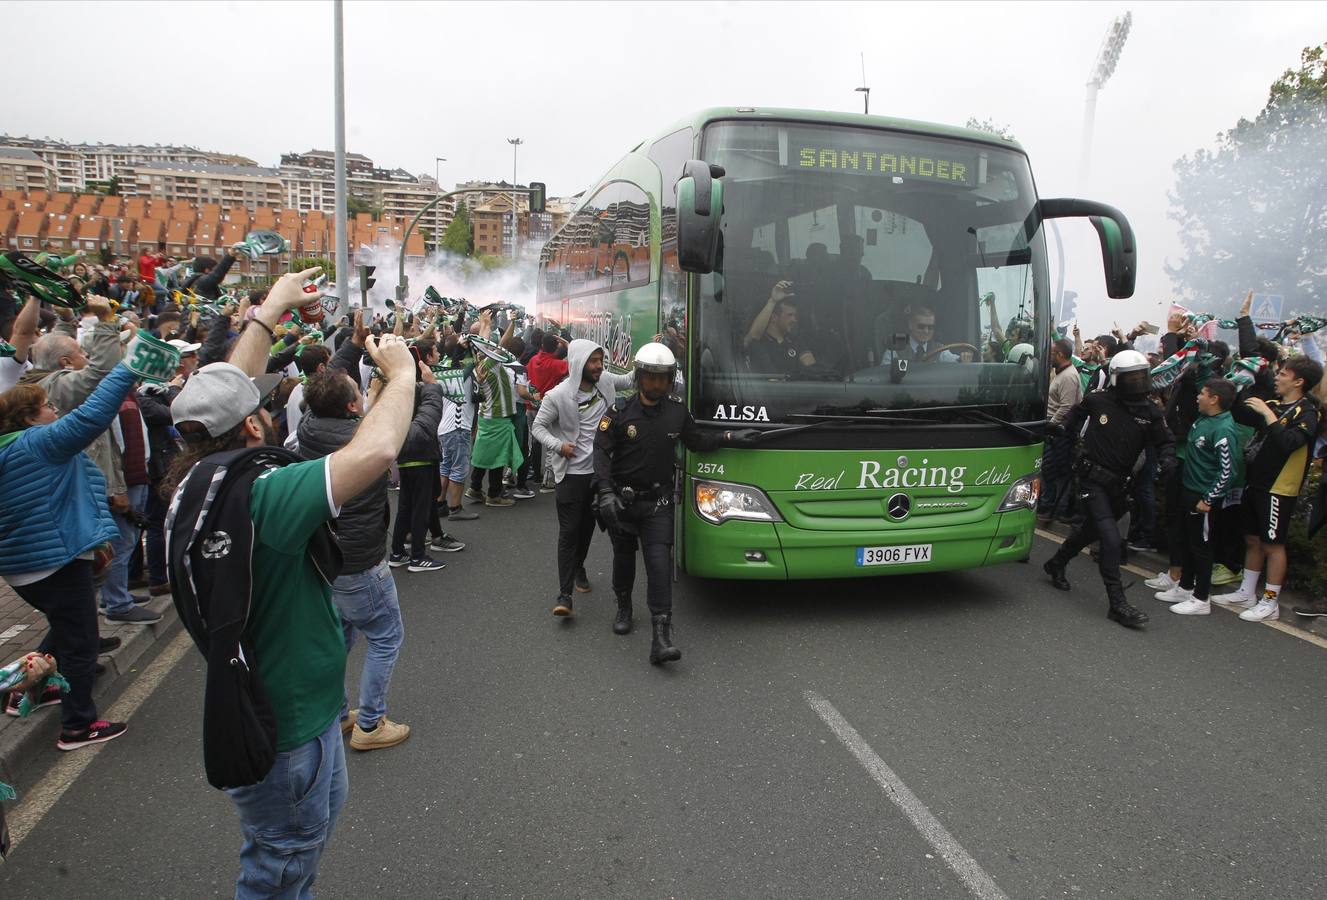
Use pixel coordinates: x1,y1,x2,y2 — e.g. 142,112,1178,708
332,563,406,731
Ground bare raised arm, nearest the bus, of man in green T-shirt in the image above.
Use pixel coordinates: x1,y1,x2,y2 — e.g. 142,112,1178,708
326,334,415,507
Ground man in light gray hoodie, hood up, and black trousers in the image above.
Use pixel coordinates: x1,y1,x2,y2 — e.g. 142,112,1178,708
532,338,633,616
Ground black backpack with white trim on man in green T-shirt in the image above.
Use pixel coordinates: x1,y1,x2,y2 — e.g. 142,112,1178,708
166,446,341,790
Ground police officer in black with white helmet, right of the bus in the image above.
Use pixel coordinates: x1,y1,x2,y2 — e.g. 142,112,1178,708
1042,350,1174,628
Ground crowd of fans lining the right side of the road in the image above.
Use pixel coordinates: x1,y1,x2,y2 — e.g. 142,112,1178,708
1038,293,1327,621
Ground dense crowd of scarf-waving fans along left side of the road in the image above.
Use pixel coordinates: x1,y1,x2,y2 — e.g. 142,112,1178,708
0,241,591,881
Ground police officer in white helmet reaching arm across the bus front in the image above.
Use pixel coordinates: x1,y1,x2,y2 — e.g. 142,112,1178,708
594,344,760,665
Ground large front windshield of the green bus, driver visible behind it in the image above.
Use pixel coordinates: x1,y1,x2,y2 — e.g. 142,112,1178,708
690,122,1051,422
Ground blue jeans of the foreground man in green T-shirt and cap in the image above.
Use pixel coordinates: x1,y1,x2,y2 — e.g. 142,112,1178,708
226,721,350,900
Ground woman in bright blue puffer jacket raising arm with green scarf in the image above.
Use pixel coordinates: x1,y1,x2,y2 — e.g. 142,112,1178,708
0,364,135,750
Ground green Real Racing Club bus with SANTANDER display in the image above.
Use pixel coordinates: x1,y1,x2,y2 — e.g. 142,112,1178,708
537,108,1136,579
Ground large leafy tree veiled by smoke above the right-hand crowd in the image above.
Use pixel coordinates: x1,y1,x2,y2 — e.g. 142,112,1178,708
1165,45,1327,316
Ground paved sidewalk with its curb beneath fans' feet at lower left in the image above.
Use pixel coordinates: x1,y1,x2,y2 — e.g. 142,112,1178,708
0,581,180,795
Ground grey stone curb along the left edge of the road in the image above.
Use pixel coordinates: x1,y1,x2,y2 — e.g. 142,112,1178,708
0,596,182,800
